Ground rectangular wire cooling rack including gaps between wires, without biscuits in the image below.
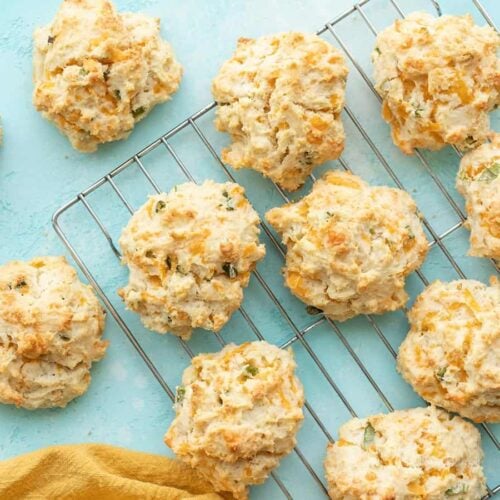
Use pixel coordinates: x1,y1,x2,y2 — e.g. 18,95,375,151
53,0,500,499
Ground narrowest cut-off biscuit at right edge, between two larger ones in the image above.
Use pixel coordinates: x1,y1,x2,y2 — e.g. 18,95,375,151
457,134,500,260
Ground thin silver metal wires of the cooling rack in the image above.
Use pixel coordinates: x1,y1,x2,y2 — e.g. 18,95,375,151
53,0,500,498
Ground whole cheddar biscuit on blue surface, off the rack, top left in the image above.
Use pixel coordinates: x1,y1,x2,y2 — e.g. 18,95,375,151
33,0,182,152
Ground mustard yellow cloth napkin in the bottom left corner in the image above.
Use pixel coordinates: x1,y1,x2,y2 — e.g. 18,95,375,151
0,444,222,500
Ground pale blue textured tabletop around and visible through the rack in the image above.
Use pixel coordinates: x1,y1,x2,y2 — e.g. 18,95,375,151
0,0,500,498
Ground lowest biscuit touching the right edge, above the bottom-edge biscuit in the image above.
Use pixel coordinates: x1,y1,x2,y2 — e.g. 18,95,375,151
398,280,500,422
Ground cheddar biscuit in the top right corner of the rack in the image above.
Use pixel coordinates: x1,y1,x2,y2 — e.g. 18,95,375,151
372,12,500,154
